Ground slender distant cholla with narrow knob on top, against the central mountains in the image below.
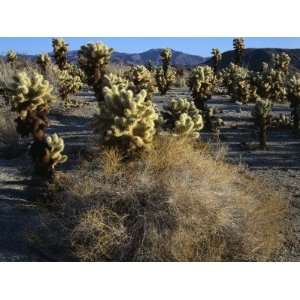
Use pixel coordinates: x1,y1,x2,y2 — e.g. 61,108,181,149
155,48,176,95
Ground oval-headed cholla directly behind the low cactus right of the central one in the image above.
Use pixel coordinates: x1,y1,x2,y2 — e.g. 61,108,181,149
188,66,215,110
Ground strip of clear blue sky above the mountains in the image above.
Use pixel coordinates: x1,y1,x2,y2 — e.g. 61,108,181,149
0,37,300,56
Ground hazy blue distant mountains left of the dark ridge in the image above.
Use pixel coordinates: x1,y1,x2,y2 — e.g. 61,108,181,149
69,49,207,66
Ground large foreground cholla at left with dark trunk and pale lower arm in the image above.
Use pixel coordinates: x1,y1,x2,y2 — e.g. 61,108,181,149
10,72,66,179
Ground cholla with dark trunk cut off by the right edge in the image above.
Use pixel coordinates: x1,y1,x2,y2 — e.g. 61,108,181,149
288,75,300,130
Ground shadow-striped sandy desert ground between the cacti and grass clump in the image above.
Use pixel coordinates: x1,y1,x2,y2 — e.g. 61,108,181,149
0,89,300,261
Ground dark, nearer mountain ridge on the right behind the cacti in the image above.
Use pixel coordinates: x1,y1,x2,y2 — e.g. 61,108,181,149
206,48,300,72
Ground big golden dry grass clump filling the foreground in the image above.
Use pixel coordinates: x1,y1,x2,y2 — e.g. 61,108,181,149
37,136,287,261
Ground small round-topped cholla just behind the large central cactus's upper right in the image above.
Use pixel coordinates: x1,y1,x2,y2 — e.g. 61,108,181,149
128,65,154,100
